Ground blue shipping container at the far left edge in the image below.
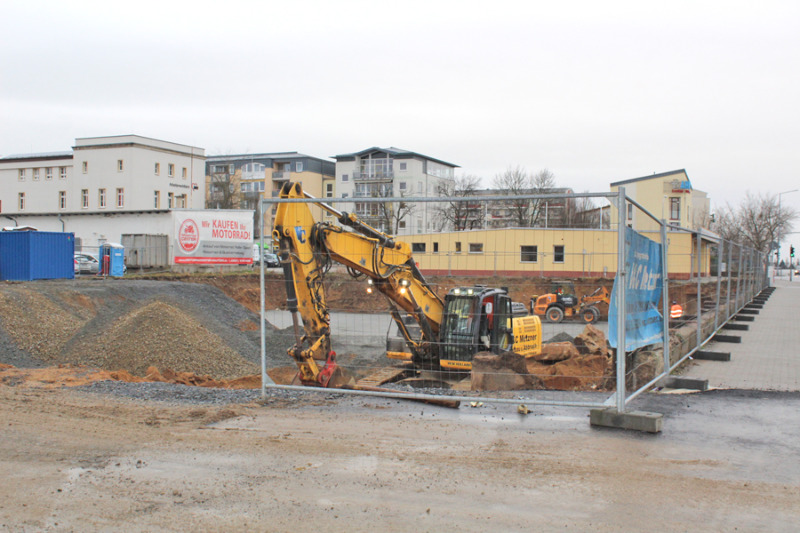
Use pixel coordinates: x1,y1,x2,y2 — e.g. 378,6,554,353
0,231,75,281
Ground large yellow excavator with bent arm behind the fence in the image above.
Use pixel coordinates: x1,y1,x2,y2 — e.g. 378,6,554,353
272,182,541,387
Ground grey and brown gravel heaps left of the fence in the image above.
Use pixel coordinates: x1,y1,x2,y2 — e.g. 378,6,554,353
0,279,292,379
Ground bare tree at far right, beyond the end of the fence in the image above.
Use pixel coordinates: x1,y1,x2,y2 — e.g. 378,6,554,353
712,191,798,252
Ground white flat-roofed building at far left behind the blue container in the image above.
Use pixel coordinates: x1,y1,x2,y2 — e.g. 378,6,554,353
0,135,205,246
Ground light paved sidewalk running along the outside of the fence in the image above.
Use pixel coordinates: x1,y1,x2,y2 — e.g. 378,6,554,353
683,280,800,391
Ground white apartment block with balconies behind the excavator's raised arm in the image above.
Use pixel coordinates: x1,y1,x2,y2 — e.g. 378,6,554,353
334,147,459,235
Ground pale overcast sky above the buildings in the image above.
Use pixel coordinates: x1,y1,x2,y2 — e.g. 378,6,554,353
0,0,800,220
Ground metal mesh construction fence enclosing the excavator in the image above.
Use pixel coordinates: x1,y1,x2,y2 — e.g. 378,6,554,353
259,188,768,412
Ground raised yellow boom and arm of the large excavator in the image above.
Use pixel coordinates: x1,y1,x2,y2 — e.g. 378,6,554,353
272,183,444,386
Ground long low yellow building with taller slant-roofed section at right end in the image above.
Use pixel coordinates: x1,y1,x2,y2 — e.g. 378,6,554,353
403,170,719,279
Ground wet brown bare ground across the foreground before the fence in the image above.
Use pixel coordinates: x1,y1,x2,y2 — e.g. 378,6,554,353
0,386,800,532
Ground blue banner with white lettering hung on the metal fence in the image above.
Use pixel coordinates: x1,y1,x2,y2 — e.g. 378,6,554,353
608,228,664,351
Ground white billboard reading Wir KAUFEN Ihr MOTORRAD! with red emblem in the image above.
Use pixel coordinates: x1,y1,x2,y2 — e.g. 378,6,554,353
173,210,253,265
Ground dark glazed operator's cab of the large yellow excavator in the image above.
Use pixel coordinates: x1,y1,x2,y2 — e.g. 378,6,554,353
439,286,514,370
